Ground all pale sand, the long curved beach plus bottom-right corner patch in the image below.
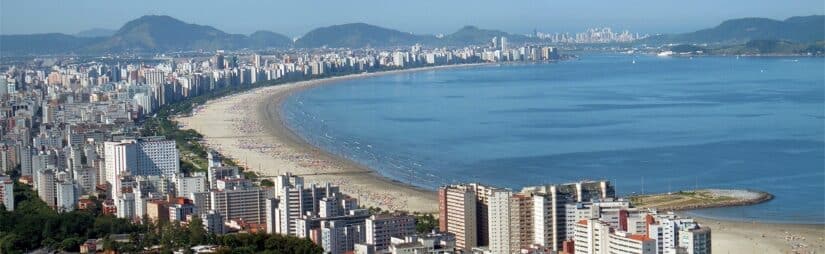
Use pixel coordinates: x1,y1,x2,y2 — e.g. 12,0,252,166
176,65,825,253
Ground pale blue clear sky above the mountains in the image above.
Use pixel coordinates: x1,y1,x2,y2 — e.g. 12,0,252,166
0,0,825,37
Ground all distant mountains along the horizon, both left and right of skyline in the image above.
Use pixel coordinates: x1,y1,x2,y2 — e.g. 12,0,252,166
0,15,825,56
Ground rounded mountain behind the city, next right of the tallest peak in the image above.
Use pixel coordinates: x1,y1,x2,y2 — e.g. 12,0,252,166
295,23,436,48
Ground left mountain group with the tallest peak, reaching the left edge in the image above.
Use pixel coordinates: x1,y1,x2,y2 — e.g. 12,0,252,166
0,15,292,55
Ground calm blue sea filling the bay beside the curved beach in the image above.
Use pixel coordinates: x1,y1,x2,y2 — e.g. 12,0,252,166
281,55,825,223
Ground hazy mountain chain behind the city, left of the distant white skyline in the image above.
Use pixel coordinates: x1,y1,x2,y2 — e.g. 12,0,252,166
0,15,530,55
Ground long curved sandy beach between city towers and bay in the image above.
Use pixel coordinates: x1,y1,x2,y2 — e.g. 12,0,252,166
174,63,495,213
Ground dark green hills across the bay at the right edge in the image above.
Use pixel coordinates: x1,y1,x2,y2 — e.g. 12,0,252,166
643,15,825,44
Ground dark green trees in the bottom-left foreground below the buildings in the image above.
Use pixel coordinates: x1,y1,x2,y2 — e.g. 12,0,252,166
0,184,323,254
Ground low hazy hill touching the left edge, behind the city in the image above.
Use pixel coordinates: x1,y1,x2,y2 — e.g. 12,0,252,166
0,33,101,56
